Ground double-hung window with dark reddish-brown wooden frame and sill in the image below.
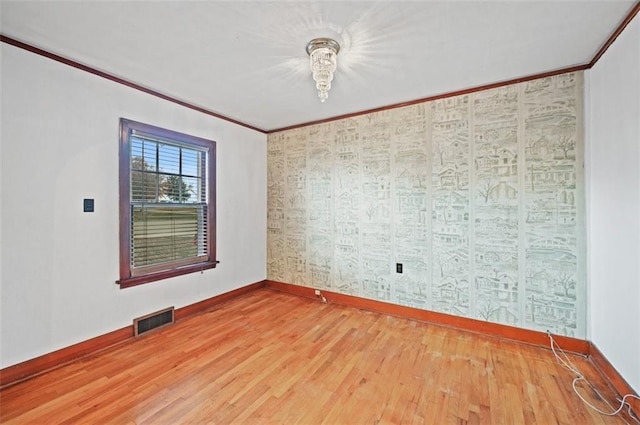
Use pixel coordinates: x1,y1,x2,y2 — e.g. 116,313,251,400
118,118,217,288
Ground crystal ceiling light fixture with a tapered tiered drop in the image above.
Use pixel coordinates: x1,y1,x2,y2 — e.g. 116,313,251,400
307,38,340,102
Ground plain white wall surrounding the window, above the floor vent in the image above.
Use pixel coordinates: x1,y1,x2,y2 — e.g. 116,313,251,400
0,43,266,367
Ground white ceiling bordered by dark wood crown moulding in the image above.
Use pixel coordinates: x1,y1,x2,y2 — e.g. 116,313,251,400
0,0,635,131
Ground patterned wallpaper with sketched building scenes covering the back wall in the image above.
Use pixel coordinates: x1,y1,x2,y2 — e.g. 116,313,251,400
267,73,586,338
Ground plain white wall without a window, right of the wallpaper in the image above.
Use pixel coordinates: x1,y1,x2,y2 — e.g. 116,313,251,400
586,16,640,392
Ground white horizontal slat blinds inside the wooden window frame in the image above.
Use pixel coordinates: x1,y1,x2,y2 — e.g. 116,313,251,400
130,131,209,275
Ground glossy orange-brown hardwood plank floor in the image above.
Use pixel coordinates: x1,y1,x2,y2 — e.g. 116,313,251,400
0,289,635,425
